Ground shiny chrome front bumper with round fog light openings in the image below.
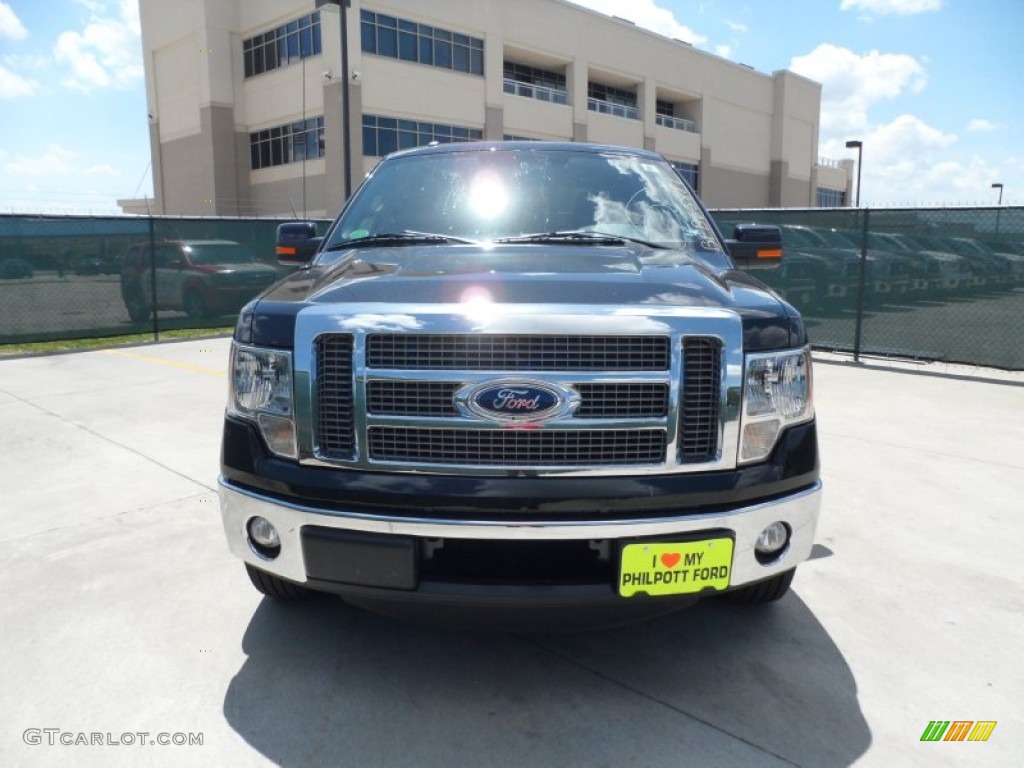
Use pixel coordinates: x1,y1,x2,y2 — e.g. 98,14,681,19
218,477,821,587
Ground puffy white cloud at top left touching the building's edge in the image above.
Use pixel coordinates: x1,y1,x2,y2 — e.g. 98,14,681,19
53,0,142,93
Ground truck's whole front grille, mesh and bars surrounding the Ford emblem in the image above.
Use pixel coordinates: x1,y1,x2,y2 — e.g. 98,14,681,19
311,333,724,472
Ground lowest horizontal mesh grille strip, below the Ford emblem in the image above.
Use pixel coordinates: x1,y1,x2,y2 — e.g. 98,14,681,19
369,426,666,467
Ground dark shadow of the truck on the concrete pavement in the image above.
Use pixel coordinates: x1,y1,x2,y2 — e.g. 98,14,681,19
224,593,871,768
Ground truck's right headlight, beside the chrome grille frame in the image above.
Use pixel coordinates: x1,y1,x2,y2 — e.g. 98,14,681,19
739,348,814,464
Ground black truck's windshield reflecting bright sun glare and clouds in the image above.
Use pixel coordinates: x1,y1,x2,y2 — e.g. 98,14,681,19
321,146,724,261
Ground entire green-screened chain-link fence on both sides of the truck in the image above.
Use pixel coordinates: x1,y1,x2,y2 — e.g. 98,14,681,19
0,207,1024,370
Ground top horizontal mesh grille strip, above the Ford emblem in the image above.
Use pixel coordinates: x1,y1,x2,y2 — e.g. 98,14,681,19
367,334,671,371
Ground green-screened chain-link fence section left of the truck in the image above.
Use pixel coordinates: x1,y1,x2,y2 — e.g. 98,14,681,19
0,216,329,344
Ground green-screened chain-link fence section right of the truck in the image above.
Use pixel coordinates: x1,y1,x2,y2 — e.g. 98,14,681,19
713,207,1024,370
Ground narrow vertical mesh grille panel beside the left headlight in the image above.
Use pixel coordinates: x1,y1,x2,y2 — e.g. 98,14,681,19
316,334,355,460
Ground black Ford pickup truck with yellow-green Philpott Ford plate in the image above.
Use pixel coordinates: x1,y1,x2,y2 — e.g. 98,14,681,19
220,142,821,628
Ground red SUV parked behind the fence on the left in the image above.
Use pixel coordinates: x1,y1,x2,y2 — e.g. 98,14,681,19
121,240,278,323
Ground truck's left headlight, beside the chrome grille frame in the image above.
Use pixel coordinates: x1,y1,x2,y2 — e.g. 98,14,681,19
227,342,298,459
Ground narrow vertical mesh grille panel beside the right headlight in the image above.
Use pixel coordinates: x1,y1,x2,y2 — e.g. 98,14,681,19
679,337,722,463
